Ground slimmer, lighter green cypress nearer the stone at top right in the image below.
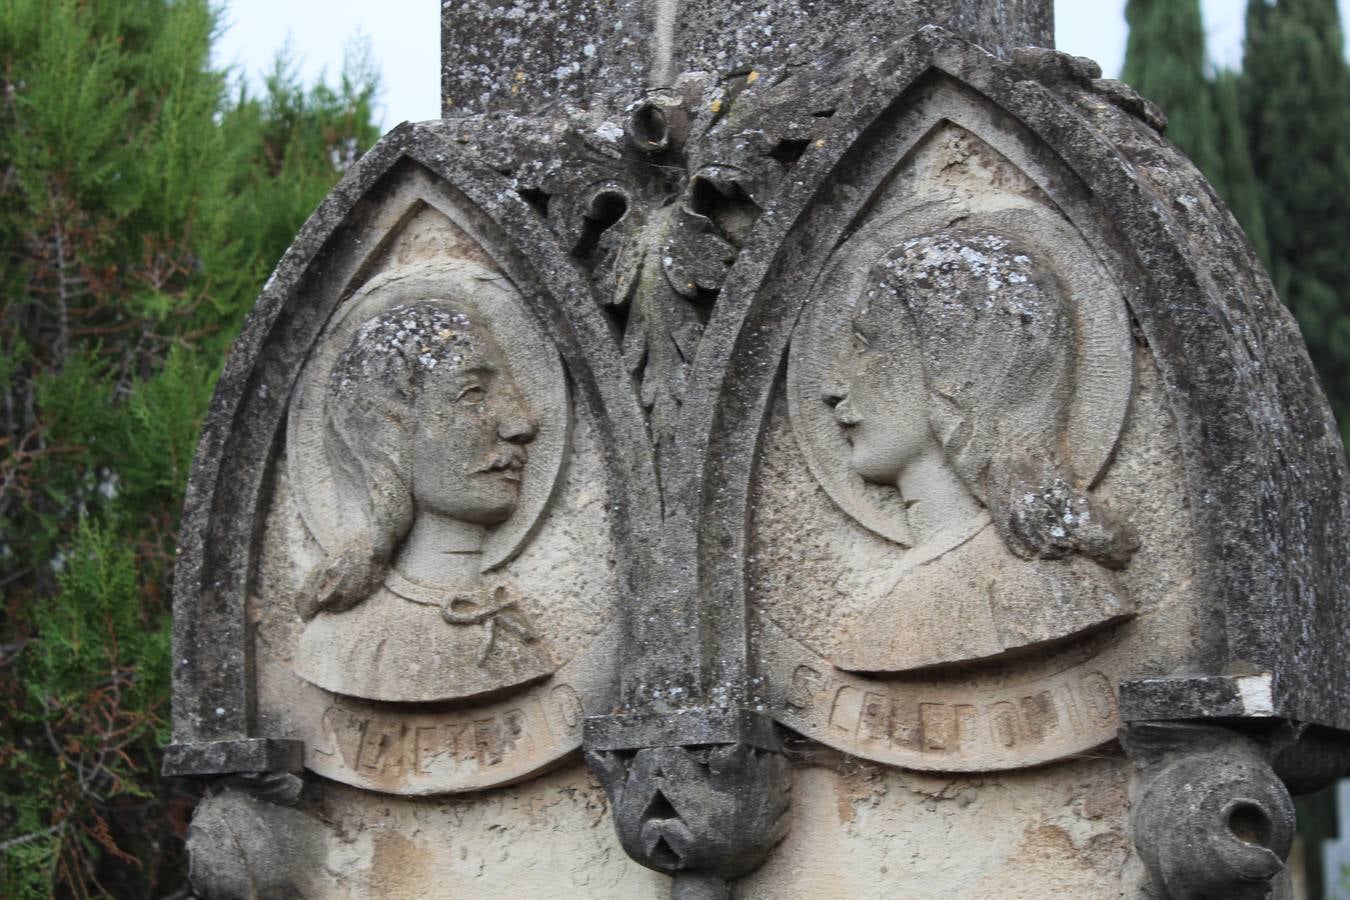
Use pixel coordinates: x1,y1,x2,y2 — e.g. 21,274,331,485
1122,0,1222,179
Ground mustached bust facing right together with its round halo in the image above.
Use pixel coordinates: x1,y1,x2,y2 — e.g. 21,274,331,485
288,260,570,702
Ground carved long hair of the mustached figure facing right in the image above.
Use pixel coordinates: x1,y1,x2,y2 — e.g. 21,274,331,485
297,300,482,619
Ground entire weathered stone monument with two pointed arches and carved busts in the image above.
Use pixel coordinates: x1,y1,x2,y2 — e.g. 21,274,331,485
165,0,1350,900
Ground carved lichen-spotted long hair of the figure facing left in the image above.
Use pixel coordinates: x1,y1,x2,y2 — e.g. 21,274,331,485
856,229,1137,567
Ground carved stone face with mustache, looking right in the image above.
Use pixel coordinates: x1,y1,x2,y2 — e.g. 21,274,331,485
410,327,537,525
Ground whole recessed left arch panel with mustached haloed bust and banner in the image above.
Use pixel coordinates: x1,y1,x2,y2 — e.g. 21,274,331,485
254,175,616,793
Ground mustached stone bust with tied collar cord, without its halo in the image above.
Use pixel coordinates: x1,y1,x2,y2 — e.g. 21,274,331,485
294,298,552,700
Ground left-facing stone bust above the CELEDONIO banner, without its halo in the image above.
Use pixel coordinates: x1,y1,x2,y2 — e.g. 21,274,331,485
822,229,1135,672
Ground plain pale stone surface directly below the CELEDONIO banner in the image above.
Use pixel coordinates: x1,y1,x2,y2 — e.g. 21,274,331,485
736,754,1148,900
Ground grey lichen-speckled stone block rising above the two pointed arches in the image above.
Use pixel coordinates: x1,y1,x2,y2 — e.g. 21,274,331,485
441,0,1054,116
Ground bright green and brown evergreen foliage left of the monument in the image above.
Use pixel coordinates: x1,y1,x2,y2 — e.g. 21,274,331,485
0,0,378,897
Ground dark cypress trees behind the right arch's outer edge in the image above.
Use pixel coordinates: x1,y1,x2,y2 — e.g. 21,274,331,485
1123,0,1350,441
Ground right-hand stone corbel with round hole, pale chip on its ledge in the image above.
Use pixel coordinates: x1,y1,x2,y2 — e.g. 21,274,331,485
1121,673,1350,900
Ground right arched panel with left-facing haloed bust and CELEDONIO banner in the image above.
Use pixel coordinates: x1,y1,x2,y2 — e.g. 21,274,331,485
749,107,1204,770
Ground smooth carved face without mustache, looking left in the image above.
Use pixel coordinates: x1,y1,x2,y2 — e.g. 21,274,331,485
824,300,936,486
